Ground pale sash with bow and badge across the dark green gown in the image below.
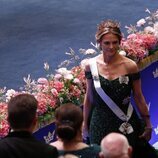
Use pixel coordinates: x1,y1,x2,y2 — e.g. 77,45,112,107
90,58,134,134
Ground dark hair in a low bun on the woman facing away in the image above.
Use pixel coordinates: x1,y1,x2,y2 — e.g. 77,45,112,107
55,103,83,141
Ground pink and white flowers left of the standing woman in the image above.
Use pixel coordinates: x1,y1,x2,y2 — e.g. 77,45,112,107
0,58,89,137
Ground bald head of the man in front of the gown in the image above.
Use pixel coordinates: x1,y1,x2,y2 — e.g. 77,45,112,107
100,132,132,158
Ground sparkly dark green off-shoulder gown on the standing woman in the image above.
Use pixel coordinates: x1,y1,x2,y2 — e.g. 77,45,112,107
86,72,158,157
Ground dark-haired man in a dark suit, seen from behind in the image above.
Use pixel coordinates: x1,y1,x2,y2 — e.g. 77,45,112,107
0,94,58,158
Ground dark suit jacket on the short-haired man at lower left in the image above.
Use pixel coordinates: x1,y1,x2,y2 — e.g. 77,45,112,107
0,131,58,158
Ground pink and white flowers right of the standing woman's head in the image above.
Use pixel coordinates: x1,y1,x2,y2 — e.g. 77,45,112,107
121,9,158,62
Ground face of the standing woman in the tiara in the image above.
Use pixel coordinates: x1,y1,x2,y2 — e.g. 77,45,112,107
100,33,119,56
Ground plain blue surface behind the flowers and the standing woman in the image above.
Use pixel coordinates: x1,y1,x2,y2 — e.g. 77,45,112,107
0,0,157,89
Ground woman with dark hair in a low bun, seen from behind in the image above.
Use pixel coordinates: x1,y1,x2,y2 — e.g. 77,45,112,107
51,103,100,158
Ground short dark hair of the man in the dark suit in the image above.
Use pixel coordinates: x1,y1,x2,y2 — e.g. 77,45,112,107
8,94,38,129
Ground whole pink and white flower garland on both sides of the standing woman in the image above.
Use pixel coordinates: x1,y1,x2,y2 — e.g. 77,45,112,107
0,9,158,138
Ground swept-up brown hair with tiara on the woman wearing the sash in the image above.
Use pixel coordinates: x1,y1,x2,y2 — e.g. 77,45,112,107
95,19,122,43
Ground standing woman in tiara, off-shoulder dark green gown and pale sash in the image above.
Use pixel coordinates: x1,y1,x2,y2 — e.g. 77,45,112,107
83,20,158,155
